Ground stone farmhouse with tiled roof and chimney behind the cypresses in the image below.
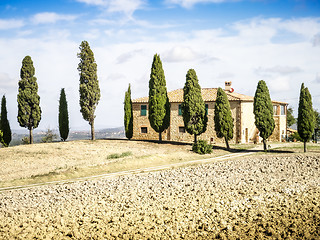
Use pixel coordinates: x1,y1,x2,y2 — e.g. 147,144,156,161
132,82,288,143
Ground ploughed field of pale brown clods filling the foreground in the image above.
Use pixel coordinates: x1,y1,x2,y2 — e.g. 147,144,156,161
0,154,320,239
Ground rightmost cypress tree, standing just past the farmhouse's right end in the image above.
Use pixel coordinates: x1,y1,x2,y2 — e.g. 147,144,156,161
298,83,315,152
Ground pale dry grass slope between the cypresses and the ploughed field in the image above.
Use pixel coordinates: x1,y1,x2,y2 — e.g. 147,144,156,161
0,140,226,187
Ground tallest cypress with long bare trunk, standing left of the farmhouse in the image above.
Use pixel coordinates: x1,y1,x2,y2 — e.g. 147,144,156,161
78,41,100,140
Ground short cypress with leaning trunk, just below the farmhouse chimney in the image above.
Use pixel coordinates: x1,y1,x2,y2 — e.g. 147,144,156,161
214,88,233,150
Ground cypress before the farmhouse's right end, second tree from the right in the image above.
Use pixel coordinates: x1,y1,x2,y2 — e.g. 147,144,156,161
253,80,275,151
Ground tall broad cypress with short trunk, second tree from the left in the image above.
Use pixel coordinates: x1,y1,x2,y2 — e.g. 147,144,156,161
17,56,41,144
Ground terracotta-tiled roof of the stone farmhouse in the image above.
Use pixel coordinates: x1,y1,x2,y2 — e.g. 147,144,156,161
132,88,282,103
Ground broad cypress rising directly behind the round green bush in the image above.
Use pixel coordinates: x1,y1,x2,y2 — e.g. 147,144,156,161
181,69,208,143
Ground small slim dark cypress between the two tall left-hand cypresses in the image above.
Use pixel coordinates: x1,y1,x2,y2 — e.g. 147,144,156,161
59,88,69,141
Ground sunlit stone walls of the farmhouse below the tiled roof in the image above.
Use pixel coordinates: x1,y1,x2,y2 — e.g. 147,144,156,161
132,101,286,144
